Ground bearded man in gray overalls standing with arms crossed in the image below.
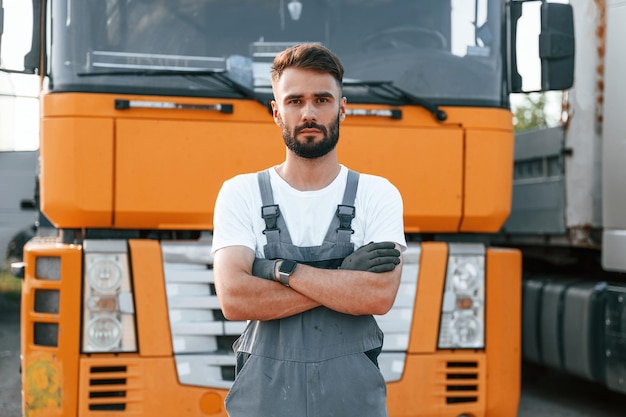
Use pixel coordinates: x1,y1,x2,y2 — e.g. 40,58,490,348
213,44,406,417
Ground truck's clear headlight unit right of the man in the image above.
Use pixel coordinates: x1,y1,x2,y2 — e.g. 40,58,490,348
438,244,485,349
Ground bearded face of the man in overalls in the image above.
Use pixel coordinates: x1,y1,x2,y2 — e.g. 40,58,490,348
272,68,346,158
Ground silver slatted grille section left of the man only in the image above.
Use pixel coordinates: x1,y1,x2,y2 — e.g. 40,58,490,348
161,240,246,388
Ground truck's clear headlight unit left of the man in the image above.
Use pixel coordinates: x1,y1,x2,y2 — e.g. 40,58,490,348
83,240,137,352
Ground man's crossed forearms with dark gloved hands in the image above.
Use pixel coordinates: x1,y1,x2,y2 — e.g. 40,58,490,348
228,242,402,320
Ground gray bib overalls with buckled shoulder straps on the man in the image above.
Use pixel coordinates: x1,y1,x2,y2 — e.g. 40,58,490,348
226,171,387,417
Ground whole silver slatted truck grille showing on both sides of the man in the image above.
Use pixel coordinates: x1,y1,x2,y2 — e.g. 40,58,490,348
161,237,421,388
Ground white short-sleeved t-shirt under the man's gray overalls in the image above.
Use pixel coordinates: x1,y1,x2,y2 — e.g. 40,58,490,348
212,165,406,258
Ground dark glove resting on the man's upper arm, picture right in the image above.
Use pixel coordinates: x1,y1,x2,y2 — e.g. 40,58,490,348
339,242,400,272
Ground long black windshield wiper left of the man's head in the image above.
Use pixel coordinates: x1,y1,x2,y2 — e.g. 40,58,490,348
76,69,272,113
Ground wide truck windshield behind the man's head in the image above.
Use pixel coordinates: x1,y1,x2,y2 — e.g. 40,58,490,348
47,0,503,106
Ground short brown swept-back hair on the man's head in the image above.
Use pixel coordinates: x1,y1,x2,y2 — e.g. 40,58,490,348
271,43,343,88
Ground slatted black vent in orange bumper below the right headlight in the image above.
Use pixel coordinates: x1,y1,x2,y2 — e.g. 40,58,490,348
446,362,478,404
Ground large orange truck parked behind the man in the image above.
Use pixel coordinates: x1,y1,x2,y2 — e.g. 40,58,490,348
5,0,573,417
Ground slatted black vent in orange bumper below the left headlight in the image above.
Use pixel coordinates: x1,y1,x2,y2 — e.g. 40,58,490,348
89,366,127,411
